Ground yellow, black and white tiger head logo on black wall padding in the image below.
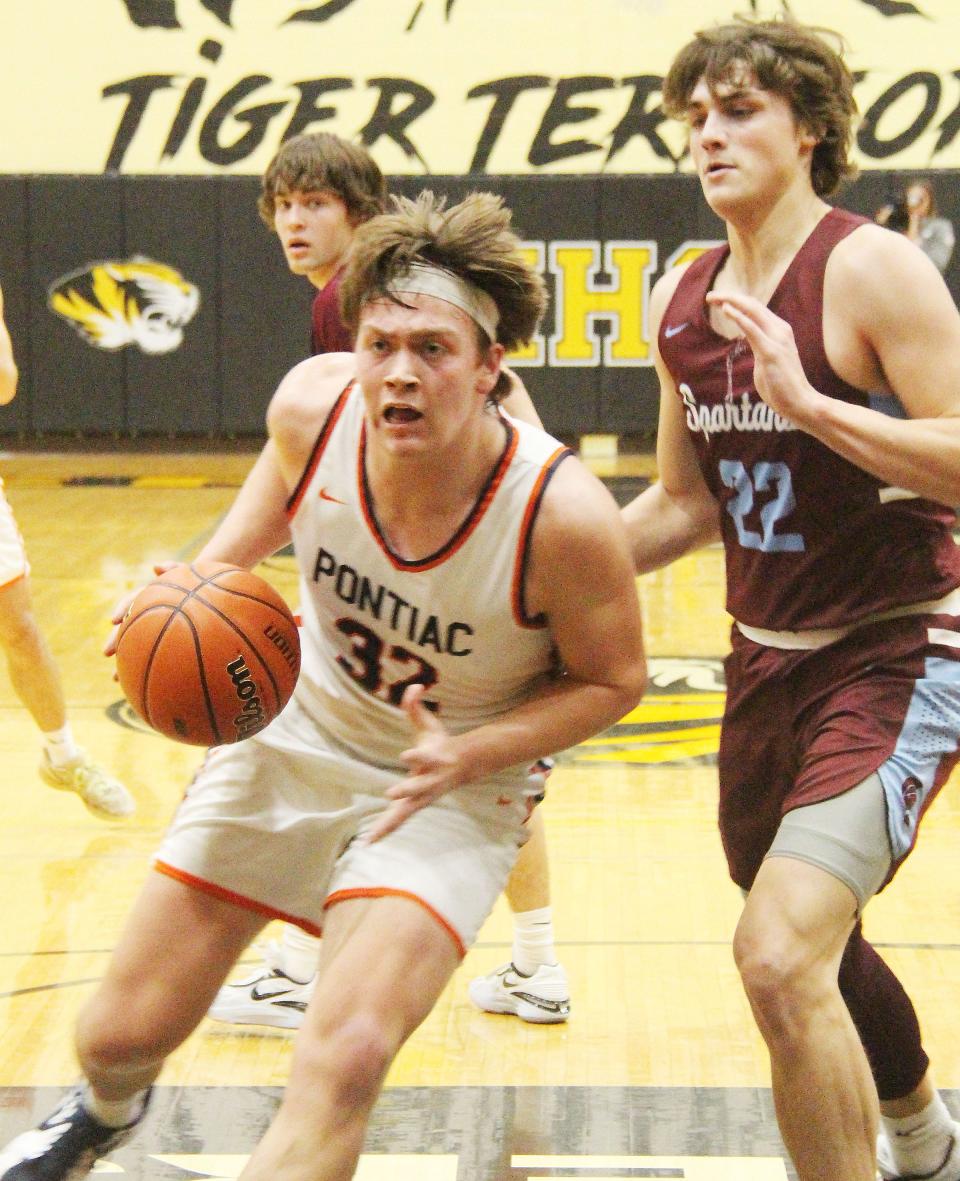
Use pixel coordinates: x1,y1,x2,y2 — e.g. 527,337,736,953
47,255,200,354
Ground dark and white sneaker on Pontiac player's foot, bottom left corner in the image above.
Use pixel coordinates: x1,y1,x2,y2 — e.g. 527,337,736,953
0,1087,150,1181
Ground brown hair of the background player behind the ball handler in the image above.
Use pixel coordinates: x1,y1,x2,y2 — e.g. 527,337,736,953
257,131,386,229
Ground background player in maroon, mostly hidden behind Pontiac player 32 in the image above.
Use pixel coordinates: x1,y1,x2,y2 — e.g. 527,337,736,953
209,132,570,1029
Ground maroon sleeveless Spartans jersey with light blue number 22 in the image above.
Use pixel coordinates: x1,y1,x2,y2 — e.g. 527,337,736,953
659,209,960,631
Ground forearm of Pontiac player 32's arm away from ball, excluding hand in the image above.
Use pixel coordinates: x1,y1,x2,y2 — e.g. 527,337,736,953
453,659,646,782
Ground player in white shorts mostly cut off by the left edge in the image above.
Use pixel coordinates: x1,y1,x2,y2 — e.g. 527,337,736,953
0,283,136,820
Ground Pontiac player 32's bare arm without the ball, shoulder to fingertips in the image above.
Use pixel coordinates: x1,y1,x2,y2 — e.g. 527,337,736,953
371,458,646,840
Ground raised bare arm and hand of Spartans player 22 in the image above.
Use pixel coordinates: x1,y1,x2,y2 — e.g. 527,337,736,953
708,226,960,505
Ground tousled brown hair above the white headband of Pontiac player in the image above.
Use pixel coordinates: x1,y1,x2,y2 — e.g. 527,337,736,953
340,189,547,400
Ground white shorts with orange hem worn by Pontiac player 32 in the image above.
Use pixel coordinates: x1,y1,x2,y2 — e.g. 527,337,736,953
156,698,529,954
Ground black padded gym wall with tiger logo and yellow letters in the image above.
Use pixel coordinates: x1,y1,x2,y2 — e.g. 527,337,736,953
0,172,960,441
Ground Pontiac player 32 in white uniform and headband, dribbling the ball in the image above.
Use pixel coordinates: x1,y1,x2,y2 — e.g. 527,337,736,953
0,193,645,1181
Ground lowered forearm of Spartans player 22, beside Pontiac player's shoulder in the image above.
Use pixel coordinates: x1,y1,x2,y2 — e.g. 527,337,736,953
621,483,720,574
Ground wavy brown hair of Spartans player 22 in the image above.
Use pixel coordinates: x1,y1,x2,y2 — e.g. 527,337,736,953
664,17,857,197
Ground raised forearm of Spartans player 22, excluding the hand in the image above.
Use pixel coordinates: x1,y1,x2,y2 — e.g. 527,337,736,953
804,397,960,507
